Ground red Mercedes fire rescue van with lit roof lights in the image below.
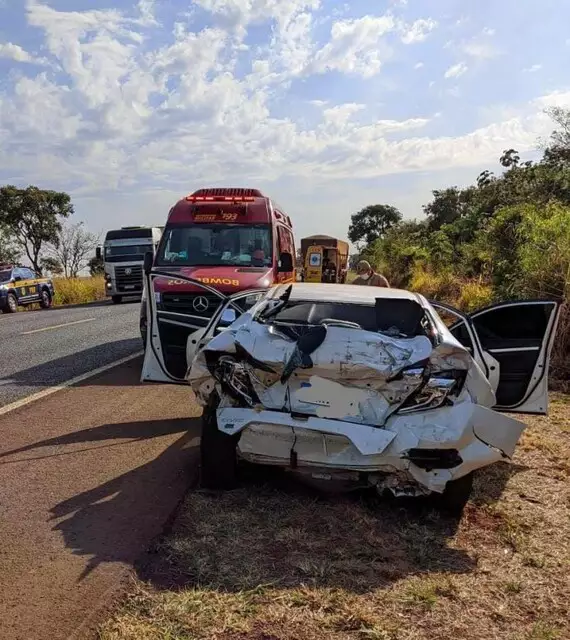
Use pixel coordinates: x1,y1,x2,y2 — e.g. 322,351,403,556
140,188,295,382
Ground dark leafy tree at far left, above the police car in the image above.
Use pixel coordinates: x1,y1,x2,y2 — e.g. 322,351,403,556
0,185,73,274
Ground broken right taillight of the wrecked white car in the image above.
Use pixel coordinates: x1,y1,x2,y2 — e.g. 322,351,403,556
397,368,467,413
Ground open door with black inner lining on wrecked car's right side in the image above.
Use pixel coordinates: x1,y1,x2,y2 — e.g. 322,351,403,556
430,300,560,415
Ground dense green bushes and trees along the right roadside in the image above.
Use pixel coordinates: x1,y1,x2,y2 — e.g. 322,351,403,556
349,108,570,389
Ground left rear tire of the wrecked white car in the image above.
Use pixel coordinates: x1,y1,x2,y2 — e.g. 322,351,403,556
200,394,239,491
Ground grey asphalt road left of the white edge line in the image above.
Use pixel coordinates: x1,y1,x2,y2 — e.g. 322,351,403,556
0,302,142,407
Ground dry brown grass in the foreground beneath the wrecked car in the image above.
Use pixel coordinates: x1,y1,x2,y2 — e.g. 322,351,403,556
100,396,570,640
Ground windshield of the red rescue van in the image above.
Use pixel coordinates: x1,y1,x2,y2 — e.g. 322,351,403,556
157,224,273,267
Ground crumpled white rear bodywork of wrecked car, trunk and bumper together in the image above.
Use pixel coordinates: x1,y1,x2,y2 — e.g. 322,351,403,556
188,314,524,493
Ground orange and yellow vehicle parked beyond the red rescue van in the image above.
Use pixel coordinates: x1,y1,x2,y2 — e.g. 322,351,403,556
301,235,348,284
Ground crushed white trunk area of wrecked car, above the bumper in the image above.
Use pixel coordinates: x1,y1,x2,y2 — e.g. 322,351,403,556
188,313,495,426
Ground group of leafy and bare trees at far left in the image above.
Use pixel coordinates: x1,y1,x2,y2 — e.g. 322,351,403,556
0,185,103,278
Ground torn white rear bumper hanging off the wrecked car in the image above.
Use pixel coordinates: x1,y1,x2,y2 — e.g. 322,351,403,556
217,401,525,495
